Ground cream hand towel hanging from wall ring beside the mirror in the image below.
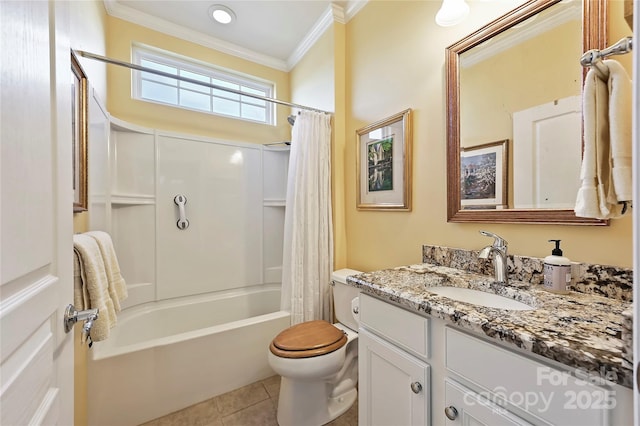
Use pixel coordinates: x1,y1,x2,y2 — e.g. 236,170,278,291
574,60,632,219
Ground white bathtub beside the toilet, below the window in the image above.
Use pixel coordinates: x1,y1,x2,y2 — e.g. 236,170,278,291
87,284,290,426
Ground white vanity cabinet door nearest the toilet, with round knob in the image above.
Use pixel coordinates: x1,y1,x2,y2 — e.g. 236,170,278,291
358,328,430,426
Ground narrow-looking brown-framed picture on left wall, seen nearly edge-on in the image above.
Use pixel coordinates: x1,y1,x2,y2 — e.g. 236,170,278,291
71,51,89,213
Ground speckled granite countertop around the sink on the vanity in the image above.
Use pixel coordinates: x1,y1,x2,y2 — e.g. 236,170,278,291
347,264,633,388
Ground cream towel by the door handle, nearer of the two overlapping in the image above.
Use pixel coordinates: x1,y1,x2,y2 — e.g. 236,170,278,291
73,234,116,342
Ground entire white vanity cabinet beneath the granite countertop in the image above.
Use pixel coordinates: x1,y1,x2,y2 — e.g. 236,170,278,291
358,293,633,426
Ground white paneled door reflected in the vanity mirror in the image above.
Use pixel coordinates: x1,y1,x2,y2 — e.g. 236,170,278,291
513,96,582,209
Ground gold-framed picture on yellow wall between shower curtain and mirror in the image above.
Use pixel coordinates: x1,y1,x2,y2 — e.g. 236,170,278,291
356,109,411,211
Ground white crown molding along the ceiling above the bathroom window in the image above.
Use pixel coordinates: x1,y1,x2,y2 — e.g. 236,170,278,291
103,0,289,72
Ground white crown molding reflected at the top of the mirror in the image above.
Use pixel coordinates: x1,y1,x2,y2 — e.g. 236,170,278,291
460,2,582,68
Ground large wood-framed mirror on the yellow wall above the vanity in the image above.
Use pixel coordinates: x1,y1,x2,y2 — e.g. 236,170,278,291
446,0,608,225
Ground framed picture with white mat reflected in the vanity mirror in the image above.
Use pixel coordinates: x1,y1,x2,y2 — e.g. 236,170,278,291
460,139,509,209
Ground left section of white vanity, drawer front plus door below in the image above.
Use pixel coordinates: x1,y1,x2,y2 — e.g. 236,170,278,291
358,295,431,426
